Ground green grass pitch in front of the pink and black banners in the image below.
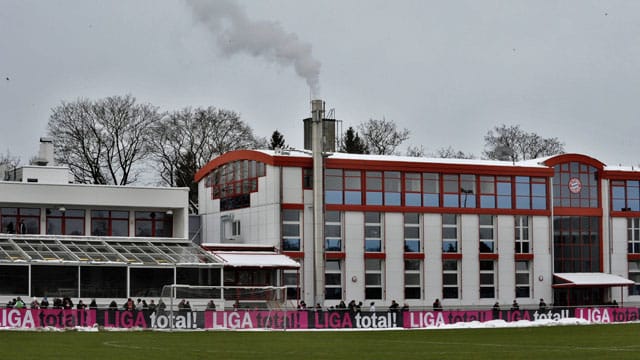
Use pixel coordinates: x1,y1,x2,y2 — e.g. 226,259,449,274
0,324,640,360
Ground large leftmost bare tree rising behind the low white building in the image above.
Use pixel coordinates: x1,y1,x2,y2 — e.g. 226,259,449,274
48,95,159,185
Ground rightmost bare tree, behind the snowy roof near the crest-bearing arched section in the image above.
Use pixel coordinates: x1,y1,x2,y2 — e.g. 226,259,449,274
484,124,564,162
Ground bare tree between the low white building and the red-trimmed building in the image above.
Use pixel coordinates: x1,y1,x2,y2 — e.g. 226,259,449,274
149,107,267,212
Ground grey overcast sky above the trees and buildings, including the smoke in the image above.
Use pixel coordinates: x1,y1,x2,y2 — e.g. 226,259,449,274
0,0,640,165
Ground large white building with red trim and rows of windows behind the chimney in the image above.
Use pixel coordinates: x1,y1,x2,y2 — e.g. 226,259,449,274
196,150,640,308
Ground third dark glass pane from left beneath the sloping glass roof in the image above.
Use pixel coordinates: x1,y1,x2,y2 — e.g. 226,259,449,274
80,266,127,298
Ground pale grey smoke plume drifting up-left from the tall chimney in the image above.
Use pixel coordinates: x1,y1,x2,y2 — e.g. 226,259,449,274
187,0,320,96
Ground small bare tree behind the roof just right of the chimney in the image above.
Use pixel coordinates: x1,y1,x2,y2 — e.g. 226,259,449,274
358,118,409,155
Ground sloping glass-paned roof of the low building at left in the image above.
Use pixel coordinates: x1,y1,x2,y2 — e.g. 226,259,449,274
0,234,221,266
